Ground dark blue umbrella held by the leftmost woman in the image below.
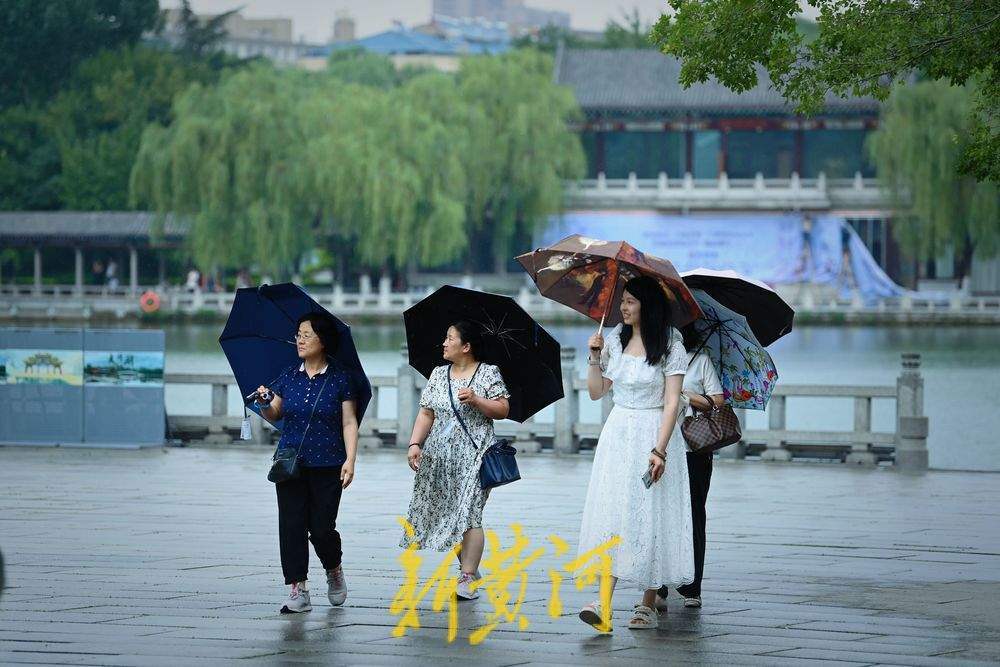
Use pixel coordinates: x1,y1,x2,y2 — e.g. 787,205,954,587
219,283,372,430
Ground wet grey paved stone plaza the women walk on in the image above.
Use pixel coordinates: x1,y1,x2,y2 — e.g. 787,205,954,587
0,448,1000,666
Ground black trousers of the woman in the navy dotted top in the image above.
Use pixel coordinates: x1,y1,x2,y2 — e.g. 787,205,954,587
274,467,344,584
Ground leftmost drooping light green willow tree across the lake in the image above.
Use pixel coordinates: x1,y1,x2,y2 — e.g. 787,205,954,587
130,66,312,272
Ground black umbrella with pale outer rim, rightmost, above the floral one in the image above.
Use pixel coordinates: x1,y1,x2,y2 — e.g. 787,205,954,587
681,269,795,347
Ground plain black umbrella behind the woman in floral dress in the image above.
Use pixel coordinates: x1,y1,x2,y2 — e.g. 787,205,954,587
403,285,563,422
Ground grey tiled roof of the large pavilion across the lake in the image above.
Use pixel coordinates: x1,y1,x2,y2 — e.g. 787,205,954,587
556,49,879,115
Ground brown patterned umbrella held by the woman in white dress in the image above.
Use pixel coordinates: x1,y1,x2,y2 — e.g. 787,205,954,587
517,234,701,327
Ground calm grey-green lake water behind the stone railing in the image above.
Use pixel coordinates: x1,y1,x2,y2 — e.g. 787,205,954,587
150,324,1000,471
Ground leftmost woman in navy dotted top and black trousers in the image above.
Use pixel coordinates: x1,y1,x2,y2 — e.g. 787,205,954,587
257,313,358,613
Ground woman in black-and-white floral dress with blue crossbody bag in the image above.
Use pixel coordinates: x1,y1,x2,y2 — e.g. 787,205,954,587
400,321,510,600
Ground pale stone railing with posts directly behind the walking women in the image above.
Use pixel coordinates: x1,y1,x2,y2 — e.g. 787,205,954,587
165,347,927,470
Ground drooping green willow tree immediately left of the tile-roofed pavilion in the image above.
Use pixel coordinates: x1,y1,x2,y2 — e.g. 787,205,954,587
456,50,586,271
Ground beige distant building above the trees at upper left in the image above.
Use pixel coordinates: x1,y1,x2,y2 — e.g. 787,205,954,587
159,9,313,65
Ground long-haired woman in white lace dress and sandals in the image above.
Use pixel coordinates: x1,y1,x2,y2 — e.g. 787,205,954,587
578,277,694,632
